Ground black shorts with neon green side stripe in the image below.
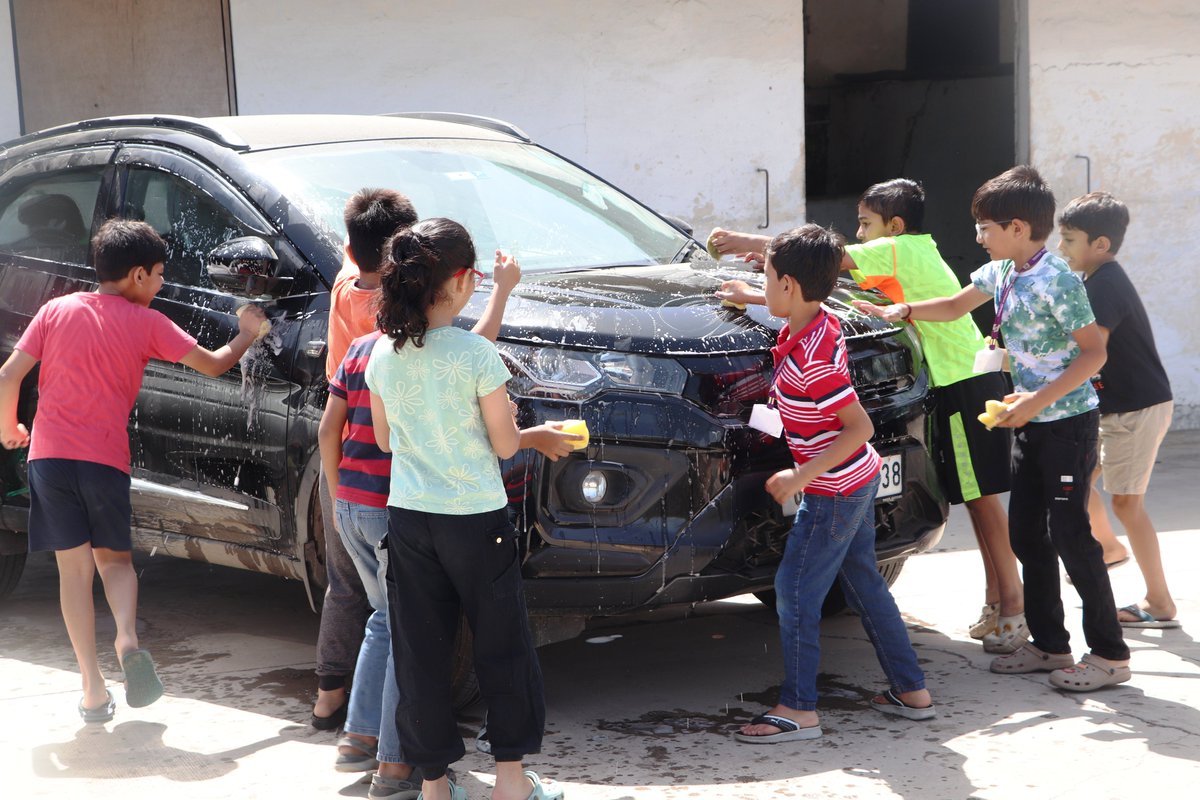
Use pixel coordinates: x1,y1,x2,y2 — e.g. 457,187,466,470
929,372,1013,505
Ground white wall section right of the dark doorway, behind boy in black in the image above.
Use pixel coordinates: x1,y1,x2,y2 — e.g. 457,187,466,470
1028,0,1200,428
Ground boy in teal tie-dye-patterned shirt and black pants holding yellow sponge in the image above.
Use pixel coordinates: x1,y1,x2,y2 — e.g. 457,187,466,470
854,167,1130,692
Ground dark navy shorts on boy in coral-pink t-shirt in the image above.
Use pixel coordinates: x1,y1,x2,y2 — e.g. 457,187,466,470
29,458,132,553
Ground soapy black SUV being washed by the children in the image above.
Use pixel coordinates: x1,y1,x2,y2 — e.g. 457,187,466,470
0,114,946,643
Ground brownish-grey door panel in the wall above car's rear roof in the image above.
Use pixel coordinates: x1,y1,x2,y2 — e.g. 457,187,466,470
10,0,236,133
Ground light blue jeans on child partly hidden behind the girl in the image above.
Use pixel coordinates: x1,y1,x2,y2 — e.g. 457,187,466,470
337,500,404,764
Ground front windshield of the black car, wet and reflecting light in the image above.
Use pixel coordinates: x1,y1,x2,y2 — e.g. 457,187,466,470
245,139,689,271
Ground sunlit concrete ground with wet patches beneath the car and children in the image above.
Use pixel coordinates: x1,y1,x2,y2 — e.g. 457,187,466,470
0,433,1200,800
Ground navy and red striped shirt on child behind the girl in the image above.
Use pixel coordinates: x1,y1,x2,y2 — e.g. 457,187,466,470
329,331,391,509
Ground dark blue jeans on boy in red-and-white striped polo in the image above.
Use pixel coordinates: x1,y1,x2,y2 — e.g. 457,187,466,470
775,476,925,711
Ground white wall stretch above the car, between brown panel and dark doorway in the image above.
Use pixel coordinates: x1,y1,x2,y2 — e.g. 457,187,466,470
230,0,804,239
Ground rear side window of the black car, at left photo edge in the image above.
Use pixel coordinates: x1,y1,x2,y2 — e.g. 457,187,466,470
0,167,104,264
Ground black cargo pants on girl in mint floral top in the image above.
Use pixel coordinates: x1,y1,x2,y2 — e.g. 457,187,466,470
388,506,546,780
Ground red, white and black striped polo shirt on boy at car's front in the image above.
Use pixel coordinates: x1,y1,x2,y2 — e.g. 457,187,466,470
770,308,880,494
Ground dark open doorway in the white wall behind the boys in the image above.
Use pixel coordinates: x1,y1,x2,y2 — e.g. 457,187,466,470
804,0,1024,304
